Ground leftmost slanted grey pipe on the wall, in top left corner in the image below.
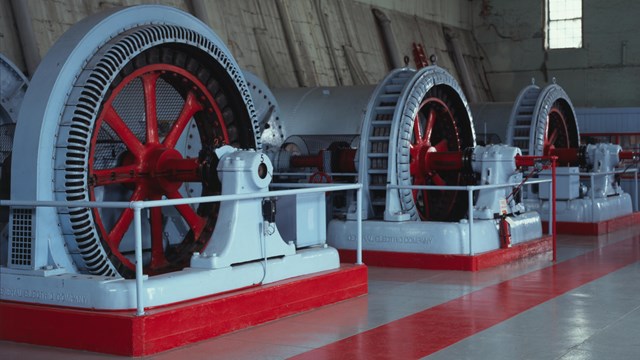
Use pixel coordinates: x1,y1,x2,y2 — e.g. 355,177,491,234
11,0,40,77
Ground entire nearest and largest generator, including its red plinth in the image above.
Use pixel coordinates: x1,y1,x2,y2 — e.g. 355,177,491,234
0,5,366,356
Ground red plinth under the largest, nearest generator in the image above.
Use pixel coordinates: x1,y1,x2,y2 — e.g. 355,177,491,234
0,264,367,356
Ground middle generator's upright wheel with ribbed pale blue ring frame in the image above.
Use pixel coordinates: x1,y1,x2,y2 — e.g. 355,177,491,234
359,66,475,221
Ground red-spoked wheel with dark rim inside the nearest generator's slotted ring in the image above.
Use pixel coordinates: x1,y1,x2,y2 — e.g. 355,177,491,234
85,44,253,272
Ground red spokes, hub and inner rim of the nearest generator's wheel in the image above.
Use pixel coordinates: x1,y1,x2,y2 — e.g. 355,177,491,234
89,64,229,273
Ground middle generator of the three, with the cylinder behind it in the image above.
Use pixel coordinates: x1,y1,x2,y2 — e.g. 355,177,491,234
262,66,548,268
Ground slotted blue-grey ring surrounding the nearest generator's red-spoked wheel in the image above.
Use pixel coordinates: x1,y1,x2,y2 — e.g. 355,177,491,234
56,24,261,278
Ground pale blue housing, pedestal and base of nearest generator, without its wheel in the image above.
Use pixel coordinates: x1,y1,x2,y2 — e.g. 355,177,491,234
0,5,339,310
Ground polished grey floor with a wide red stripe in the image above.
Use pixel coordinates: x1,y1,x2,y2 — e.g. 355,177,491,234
0,225,640,360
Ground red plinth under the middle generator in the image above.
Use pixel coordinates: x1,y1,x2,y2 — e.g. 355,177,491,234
338,235,553,271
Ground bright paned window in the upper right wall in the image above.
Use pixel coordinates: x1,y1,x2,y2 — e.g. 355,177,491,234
545,0,582,49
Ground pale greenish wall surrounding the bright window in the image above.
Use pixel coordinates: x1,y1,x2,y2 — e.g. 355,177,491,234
472,0,640,107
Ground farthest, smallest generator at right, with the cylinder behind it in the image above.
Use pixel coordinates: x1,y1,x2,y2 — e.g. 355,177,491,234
472,79,639,234
